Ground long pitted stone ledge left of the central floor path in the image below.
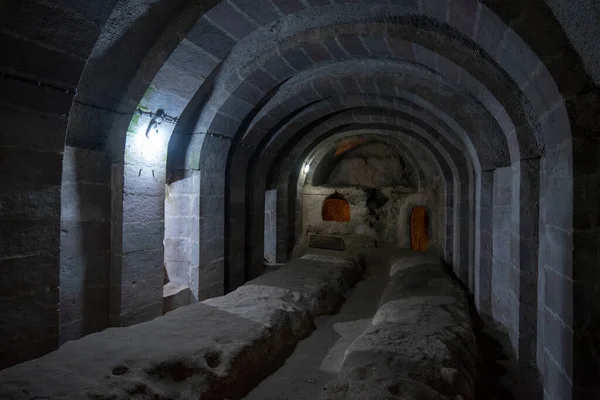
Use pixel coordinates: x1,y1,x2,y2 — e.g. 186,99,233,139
0,254,363,400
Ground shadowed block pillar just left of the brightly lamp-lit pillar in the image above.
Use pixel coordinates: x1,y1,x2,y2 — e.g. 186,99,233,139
60,146,111,344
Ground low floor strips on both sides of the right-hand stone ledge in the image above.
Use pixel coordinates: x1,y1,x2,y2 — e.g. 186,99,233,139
245,248,543,400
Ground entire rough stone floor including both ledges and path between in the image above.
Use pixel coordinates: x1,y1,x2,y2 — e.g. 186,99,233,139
0,248,541,400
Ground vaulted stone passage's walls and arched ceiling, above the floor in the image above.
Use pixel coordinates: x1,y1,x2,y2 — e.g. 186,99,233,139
0,0,600,399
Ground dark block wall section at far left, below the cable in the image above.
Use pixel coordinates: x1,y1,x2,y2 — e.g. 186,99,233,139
0,82,73,368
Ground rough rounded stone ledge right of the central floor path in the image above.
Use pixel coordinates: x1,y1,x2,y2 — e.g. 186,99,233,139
321,252,476,400
